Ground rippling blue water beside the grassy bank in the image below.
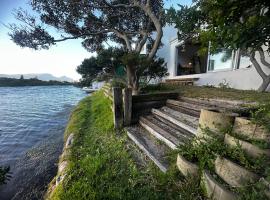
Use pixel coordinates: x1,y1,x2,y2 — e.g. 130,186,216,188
0,86,86,199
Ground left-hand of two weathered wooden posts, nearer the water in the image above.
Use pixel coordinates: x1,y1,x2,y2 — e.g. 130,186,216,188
113,87,123,129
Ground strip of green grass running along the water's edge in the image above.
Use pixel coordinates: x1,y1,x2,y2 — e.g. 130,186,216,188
50,92,202,200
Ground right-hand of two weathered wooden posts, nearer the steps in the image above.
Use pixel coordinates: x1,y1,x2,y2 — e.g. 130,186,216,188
123,88,132,126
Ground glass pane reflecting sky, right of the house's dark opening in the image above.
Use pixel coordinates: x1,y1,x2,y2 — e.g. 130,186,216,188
208,50,233,71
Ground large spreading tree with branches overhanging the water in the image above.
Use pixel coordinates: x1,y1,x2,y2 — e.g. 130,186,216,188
10,0,164,93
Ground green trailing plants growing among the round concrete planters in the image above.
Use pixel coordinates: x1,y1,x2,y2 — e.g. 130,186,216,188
179,127,267,176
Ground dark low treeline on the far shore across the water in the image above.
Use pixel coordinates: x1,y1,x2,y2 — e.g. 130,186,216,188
0,77,73,87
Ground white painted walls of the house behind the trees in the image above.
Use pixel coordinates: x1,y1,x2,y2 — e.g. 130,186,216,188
157,27,270,91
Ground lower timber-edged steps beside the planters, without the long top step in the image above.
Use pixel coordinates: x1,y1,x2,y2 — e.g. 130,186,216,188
127,99,199,172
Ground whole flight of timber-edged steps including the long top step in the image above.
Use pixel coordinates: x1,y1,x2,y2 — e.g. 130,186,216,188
127,97,248,172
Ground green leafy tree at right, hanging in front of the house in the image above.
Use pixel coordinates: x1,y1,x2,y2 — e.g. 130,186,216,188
168,0,270,91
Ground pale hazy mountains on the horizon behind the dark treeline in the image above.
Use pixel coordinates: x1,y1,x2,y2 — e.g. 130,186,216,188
0,74,74,82
